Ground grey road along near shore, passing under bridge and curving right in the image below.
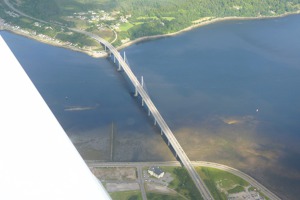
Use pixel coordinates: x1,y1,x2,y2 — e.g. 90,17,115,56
86,160,280,200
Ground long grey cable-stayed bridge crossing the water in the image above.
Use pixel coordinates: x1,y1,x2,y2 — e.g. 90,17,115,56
81,32,213,200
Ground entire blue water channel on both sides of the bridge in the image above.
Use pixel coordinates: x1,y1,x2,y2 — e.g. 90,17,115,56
1,15,300,199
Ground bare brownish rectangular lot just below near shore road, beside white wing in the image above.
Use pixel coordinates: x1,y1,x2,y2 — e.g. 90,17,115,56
91,167,137,181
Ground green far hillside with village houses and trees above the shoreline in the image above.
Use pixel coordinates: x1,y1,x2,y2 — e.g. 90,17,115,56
0,0,300,51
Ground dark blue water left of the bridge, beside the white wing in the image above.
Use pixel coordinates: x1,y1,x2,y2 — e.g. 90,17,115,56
1,32,174,161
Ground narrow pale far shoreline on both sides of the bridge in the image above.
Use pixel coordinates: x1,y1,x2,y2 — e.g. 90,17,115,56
0,10,300,58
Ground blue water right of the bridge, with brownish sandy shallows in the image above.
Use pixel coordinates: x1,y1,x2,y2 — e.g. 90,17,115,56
127,15,300,199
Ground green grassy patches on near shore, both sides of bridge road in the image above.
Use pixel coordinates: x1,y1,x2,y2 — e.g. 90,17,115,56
101,166,268,200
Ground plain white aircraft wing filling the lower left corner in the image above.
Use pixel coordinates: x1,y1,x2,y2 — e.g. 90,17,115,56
0,35,110,200
